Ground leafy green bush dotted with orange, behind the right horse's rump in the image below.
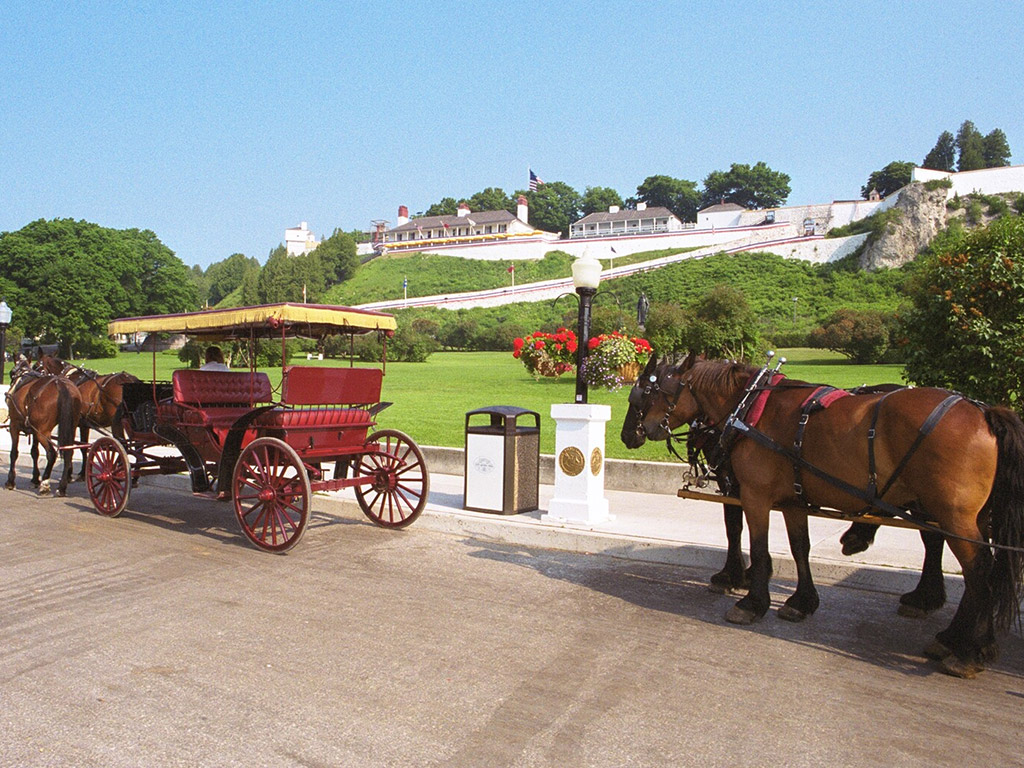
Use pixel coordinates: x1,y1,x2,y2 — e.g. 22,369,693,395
903,216,1024,413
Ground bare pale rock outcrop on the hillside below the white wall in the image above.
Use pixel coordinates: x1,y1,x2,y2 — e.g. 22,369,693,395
860,182,947,270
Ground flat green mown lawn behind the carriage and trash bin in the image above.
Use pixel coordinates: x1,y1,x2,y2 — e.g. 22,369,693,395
70,348,902,461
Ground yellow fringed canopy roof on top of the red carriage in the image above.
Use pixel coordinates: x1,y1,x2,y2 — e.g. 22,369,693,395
106,303,396,339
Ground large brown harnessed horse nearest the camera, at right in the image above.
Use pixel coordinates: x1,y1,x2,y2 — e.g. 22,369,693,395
622,360,1024,677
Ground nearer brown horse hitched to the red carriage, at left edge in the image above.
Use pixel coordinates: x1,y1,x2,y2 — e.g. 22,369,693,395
5,360,82,496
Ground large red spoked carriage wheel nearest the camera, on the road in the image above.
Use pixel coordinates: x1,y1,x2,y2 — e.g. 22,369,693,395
231,437,312,552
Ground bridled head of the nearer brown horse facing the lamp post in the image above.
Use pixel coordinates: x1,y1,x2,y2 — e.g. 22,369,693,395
620,353,700,449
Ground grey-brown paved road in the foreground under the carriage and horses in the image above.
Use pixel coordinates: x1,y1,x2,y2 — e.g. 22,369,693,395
0,484,1024,768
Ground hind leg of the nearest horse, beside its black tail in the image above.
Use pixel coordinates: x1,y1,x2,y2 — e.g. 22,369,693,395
925,532,998,678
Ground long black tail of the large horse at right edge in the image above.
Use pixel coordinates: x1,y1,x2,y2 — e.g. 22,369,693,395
985,407,1024,630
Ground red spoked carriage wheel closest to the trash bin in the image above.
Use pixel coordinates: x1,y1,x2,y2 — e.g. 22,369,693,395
355,429,430,528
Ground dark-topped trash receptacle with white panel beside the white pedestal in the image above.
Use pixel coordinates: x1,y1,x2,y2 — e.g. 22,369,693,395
463,406,541,515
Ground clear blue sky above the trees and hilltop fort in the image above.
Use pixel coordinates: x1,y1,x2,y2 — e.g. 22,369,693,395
0,0,1024,266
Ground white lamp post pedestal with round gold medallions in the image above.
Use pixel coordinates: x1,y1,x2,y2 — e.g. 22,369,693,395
542,402,612,525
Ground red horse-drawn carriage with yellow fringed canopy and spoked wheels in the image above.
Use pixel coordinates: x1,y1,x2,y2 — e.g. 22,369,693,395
85,303,429,552
